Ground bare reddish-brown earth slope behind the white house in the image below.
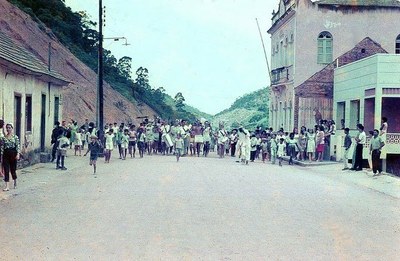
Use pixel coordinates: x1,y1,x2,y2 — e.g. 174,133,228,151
0,0,155,125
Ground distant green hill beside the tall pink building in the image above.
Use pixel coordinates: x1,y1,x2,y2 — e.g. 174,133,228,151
212,88,269,129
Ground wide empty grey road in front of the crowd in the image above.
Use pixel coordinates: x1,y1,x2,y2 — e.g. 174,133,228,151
0,151,400,260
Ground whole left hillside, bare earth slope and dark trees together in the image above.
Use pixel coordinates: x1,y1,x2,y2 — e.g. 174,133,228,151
4,0,208,121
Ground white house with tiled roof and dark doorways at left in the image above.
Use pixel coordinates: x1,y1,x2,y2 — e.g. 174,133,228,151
0,33,69,160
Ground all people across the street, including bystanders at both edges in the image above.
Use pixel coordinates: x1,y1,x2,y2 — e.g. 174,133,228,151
0,117,388,191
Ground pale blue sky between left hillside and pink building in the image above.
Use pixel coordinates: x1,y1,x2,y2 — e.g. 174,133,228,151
65,0,279,114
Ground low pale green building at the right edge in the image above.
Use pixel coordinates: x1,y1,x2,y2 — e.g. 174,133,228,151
333,54,400,174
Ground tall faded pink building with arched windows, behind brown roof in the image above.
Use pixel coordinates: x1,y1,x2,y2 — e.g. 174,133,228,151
268,0,400,131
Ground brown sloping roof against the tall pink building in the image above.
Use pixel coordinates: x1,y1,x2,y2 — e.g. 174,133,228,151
295,37,387,98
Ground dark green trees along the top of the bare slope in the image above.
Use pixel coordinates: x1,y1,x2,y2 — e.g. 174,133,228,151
9,0,206,119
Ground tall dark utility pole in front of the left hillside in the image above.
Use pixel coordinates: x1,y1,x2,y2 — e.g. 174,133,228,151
96,0,104,142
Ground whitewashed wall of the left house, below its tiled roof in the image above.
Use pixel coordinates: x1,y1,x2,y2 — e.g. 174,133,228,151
0,67,62,153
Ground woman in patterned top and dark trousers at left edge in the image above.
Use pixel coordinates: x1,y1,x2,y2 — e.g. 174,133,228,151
1,123,21,191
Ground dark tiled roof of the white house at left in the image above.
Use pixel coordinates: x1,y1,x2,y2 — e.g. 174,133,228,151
0,32,70,85
